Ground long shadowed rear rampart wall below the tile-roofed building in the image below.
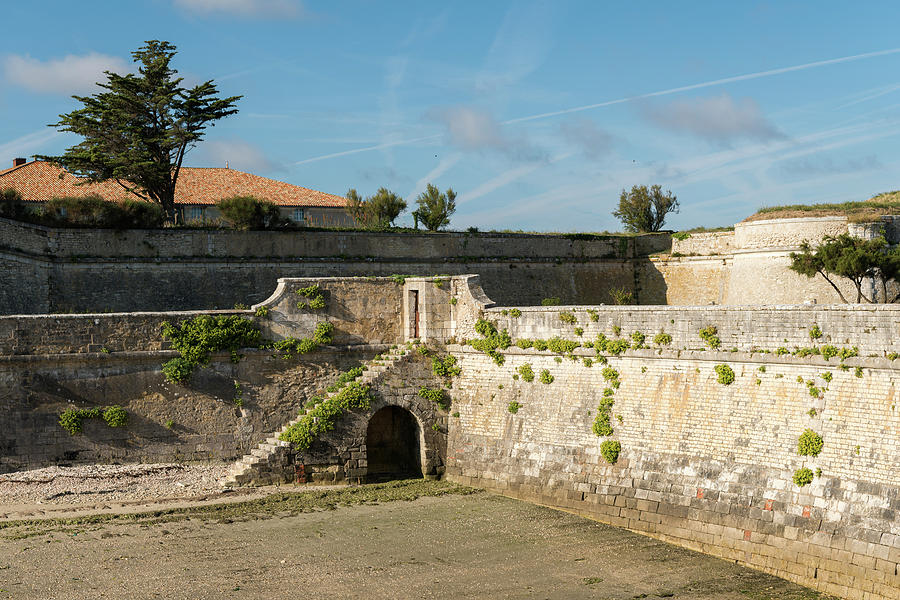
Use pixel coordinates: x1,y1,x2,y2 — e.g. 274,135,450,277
0,219,670,314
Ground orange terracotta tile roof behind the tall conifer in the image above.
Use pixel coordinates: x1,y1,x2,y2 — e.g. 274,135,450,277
0,160,347,208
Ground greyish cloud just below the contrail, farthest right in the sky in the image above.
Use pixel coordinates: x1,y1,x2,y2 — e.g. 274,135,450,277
641,94,785,143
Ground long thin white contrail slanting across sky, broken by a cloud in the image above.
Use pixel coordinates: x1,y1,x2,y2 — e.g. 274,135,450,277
294,48,900,165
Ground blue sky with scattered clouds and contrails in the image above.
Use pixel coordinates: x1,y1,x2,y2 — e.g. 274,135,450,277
0,0,900,231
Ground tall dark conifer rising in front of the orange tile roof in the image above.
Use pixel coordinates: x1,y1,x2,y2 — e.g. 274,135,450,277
38,40,241,222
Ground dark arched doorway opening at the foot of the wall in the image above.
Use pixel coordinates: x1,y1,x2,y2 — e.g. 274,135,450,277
366,406,422,481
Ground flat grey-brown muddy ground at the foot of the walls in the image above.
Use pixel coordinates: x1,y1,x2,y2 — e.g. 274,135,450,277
0,480,825,600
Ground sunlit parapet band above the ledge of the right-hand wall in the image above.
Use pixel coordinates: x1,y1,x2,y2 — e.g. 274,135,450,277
472,304,900,360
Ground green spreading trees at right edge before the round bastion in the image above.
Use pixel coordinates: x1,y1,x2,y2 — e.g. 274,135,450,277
791,233,900,304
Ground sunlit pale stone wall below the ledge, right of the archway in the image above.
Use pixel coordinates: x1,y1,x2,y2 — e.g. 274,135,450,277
447,344,900,598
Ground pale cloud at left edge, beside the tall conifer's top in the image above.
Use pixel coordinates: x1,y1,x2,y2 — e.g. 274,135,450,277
3,52,128,94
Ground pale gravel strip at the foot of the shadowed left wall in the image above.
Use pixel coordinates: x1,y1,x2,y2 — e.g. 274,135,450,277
0,464,228,505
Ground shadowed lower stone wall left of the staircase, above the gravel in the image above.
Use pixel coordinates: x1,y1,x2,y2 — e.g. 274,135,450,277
0,346,383,473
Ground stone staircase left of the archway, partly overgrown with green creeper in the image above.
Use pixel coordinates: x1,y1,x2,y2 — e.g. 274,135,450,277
220,344,416,487
